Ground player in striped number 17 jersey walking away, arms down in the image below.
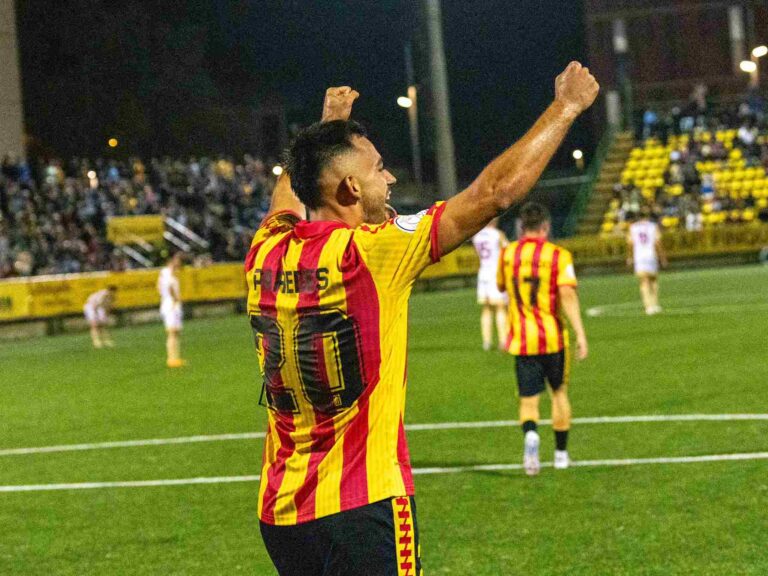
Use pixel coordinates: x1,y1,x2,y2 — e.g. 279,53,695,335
498,202,587,476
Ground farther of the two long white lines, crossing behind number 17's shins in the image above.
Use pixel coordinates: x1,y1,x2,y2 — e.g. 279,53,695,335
0,414,768,456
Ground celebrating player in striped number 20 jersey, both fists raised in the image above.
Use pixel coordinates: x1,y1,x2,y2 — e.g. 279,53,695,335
245,62,598,576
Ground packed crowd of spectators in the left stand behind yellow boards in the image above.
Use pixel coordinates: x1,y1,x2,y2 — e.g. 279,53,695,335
0,155,274,278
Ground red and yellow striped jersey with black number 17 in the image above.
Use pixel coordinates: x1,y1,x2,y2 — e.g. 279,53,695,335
496,237,576,356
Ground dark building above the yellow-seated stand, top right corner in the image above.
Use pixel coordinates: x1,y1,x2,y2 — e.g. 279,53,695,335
584,0,768,115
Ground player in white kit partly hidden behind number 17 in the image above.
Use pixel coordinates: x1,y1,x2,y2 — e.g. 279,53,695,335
472,218,509,350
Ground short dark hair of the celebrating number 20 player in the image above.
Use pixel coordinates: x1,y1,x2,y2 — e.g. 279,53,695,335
284,120,366,210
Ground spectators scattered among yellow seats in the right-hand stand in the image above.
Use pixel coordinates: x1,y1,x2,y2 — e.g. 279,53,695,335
602,85,768,234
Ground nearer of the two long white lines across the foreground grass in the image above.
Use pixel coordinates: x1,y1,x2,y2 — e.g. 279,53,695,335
0,452,768,493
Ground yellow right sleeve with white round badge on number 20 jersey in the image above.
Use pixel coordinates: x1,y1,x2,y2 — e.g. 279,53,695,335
353,202,445,288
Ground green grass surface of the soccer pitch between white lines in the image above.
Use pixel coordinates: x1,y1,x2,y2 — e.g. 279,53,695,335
0,268,768,576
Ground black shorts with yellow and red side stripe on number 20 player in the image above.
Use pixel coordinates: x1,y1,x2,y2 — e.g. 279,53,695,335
261,496,421,576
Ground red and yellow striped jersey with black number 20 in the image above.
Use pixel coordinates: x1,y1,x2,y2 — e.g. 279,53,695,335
246,203,445,525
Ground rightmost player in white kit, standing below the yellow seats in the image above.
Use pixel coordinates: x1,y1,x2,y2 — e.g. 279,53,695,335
627,211,667,315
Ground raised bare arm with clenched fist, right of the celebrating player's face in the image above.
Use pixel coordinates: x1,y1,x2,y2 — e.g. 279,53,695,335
438,62,599,254
